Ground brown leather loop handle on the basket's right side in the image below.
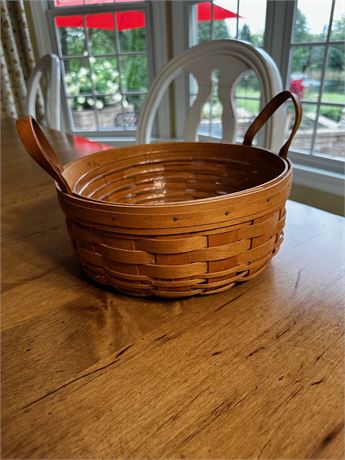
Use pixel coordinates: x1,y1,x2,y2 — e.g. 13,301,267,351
243,91,302,158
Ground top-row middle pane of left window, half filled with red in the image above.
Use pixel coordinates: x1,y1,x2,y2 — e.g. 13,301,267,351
86,13,116,55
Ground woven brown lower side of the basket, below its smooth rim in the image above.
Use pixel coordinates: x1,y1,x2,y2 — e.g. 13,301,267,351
67,207,285,297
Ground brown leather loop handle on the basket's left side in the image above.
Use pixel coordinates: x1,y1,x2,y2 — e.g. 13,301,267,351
16,115,72,195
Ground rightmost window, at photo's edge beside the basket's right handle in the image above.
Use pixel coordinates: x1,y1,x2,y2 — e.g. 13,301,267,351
289,0,345,160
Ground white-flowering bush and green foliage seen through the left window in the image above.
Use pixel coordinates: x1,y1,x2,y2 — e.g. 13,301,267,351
60,27,148,110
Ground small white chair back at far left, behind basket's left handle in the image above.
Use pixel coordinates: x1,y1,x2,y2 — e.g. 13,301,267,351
26,54,61,130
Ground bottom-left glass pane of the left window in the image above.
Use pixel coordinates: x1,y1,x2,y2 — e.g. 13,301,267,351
68,97,97,131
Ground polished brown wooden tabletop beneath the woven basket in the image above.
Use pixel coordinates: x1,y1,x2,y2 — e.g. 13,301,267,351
1,121,345,459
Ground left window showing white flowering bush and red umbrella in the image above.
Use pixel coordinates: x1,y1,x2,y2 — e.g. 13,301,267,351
48,0,153,136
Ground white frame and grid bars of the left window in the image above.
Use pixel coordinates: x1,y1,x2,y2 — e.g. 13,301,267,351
47,0,154,137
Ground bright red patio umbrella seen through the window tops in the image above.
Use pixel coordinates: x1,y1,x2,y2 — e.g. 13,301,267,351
55,0,238,31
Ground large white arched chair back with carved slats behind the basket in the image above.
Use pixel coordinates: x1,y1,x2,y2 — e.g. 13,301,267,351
137,39,285,150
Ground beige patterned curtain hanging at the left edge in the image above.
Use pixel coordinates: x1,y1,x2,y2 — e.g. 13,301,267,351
0,0,43,118
